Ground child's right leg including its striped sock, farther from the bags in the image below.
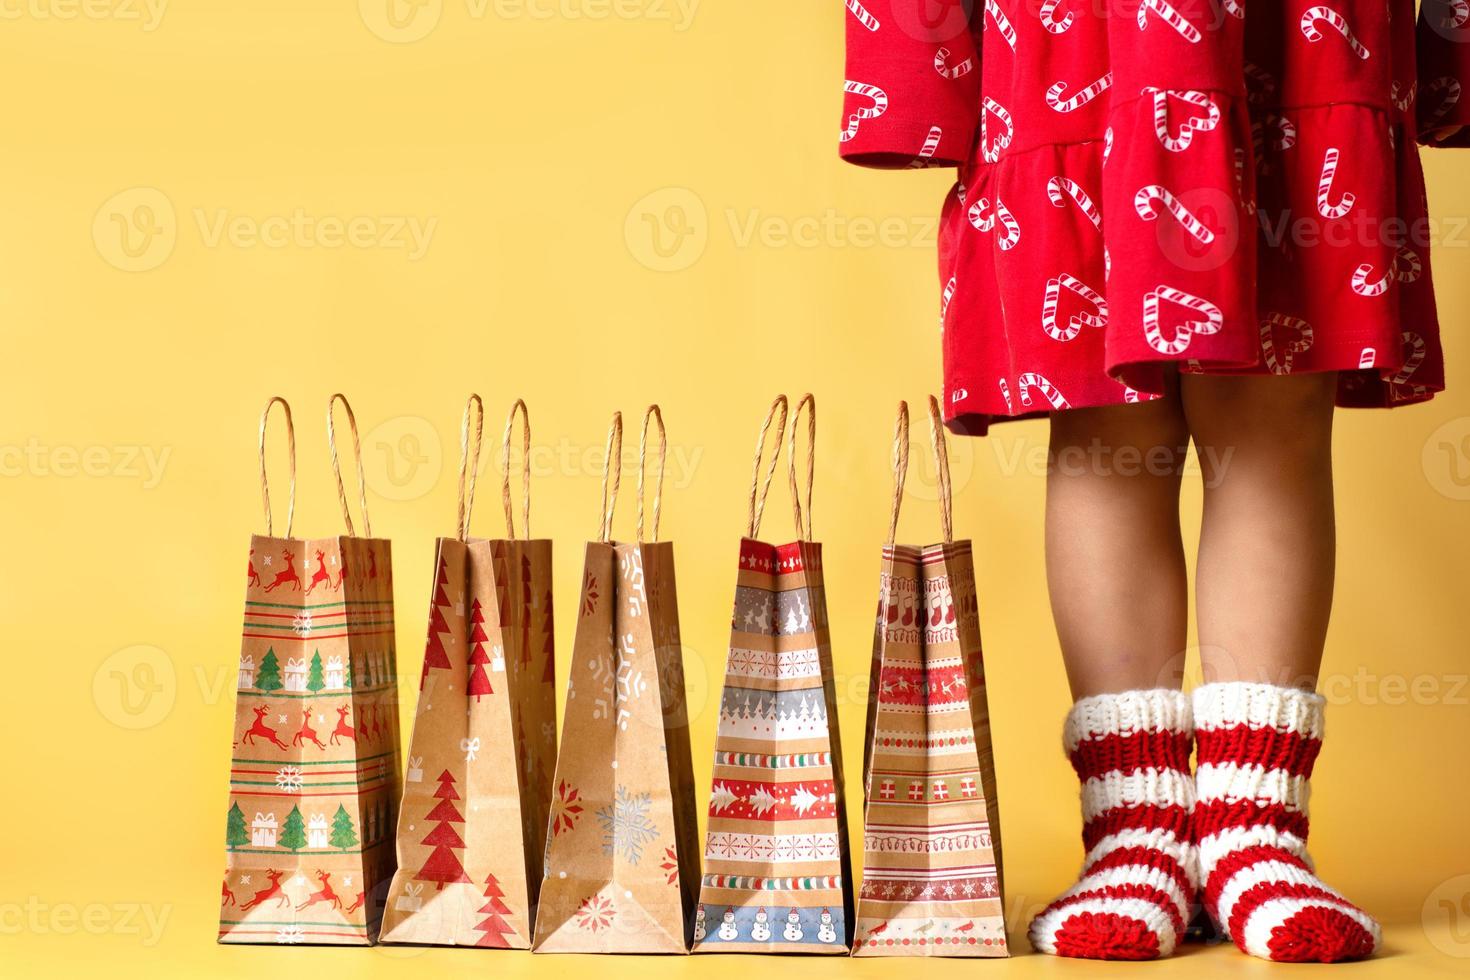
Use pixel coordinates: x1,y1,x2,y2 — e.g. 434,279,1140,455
1183,375,1380,962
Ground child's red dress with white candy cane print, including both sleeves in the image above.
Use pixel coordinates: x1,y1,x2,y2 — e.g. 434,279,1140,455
841,0,1470,433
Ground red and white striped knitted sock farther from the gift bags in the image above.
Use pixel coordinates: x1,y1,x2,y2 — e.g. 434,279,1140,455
1194,683,1382,962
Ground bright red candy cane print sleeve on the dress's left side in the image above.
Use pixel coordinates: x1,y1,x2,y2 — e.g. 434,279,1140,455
838,0,985,169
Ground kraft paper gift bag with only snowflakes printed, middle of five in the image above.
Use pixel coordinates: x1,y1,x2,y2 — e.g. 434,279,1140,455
534,406,698,954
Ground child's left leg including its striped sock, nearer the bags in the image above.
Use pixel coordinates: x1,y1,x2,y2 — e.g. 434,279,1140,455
1030,395,1198,959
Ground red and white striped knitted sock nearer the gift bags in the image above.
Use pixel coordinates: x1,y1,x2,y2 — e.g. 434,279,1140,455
1030,691,1200,959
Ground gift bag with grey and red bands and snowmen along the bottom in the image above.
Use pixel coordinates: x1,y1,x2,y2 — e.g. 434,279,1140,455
694,395,853,954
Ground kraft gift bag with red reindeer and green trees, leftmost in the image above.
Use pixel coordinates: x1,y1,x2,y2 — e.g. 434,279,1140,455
219,395,398,945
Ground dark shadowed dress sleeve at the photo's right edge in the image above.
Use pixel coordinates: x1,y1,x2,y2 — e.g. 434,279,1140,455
1416,0,1470,147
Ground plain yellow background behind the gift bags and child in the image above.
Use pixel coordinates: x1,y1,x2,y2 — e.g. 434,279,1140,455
0,0,1470,979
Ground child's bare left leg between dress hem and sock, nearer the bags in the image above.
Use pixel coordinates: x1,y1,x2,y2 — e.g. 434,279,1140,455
1047,394,1189,698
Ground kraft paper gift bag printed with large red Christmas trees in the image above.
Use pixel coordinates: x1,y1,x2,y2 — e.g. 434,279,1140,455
382,395,556,949
